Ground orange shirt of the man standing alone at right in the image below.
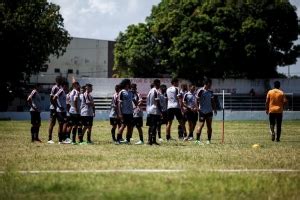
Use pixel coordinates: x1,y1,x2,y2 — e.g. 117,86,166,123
266,88,287,113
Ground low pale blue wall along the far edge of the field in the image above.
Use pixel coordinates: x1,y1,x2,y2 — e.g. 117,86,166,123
0,111,300,120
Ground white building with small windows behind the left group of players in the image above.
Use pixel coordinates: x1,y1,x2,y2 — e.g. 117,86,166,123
30,38,114,85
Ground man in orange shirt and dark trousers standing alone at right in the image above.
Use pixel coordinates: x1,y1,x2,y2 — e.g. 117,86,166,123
266,81,287,142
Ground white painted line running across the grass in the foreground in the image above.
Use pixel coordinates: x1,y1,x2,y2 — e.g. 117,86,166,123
0,169,300,174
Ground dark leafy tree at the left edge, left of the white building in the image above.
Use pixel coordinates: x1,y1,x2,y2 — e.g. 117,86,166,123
0,0,71,110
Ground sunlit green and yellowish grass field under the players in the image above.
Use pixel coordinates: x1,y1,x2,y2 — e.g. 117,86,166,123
0,121,300,200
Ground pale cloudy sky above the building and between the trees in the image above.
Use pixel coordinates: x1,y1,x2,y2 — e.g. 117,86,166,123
48,0,300,76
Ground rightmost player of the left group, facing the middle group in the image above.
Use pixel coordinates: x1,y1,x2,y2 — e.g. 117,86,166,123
79,83,95,144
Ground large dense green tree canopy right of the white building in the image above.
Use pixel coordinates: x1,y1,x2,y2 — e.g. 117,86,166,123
115,0,300,80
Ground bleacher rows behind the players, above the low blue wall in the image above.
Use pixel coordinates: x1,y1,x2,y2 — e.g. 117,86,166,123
94,94,300,111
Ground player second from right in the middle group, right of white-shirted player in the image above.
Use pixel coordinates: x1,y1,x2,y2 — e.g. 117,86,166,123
183,84,198,140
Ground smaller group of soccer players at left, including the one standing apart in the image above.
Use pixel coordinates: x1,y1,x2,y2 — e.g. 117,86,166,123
27,76,95,144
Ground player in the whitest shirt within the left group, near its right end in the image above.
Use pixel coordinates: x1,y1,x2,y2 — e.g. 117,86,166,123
69,81,81,144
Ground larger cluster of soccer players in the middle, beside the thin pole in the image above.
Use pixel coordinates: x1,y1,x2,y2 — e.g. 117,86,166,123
109,79,217,145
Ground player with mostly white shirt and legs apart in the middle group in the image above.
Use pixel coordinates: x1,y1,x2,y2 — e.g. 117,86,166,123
166,78,186,141
